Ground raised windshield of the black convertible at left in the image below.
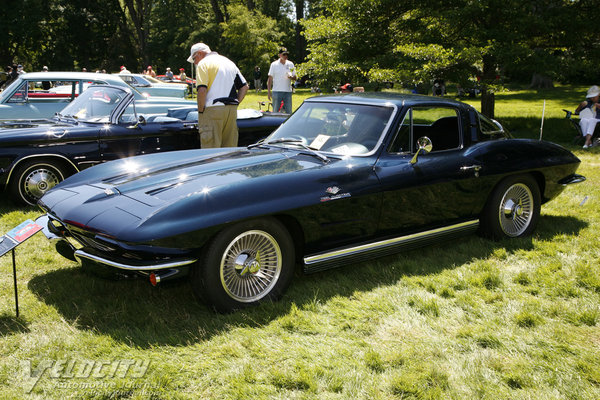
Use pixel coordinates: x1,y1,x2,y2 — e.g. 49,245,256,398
60,86,128,123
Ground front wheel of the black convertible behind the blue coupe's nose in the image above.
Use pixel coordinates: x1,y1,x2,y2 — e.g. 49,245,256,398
9,160,66,205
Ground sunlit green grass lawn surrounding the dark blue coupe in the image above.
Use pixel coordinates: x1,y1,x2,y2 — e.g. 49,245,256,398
0,86,600,400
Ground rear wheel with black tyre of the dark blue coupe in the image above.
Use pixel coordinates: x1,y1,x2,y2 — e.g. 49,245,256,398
481,175,541,240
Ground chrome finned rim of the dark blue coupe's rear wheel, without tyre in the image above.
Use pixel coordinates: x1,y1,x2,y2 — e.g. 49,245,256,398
499,183,534,237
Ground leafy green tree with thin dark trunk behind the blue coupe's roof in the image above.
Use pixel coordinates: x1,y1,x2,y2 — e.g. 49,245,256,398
300,0,593,116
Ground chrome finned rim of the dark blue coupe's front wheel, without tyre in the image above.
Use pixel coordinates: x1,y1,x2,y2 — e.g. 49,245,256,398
220,230,282,303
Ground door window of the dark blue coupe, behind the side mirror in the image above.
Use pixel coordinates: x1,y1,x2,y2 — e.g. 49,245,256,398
411,106,462,152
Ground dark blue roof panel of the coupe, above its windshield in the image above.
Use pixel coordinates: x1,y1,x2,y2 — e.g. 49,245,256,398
306,92,472,108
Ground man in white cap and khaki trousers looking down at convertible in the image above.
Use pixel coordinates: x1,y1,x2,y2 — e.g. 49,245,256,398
188,43,248,149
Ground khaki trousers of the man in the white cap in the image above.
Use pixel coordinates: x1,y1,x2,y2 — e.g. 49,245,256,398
198,106,238,149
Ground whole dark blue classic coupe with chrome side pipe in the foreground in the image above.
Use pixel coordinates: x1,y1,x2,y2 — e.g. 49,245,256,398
39,94,585,311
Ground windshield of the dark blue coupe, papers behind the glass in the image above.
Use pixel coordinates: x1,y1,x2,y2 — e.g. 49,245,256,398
264,102,394,155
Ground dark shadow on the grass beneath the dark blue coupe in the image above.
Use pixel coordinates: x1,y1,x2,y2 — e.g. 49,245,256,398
29,216,586,348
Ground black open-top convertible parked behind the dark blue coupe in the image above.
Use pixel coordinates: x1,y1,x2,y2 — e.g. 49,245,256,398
0,86,287,205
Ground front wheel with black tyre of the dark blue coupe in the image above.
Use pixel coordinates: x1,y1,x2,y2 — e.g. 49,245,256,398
192,218,295,312
